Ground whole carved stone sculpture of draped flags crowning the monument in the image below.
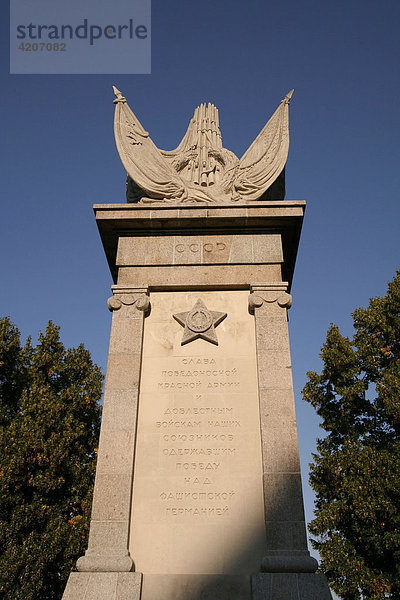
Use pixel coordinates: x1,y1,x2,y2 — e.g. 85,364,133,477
114,87,293,202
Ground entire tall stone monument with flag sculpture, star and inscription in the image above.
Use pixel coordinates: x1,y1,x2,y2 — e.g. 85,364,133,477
63,88,331,600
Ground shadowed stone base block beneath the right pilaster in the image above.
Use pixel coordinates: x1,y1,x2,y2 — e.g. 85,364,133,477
251,573,332,600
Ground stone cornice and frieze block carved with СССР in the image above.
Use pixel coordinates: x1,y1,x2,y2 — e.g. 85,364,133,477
94,200,305,289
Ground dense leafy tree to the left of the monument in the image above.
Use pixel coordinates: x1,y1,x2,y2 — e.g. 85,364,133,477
0,318,103,600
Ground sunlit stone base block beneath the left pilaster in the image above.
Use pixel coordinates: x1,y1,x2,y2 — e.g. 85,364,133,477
63,572,142,600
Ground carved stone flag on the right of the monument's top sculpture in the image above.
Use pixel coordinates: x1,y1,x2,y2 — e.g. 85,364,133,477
233,90,294,200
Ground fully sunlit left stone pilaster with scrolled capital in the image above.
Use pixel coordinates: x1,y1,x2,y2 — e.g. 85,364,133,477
77,286,149,580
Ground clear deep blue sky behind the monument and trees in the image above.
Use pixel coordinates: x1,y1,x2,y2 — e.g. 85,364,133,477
0,0,400,568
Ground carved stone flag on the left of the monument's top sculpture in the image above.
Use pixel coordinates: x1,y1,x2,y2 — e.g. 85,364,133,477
114,87,187,199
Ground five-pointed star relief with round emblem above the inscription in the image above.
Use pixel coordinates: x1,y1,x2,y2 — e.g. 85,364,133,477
172,299,227,346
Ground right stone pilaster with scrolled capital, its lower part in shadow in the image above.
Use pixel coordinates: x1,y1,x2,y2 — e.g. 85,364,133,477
249,282,317,573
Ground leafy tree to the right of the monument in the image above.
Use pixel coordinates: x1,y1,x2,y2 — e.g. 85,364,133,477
303,271,400,600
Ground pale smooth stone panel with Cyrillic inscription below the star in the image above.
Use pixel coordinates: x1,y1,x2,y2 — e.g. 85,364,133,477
130,291,265,574
